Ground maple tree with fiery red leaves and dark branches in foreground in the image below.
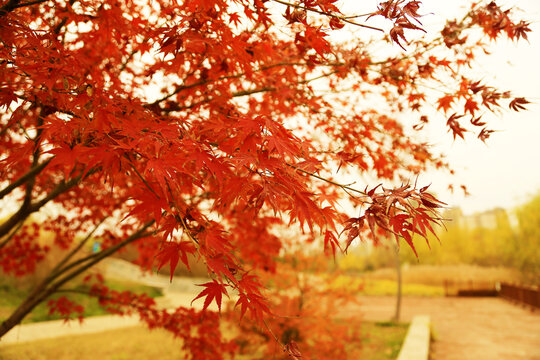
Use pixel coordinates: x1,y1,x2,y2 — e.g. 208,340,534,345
0,0,530,359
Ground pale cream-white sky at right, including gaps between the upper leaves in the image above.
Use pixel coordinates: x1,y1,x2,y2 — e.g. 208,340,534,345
326,0,540,214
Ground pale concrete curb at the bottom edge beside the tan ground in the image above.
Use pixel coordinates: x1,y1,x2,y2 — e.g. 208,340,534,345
397,315,431,360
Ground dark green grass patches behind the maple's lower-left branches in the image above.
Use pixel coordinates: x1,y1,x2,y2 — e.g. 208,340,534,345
0,280,162,323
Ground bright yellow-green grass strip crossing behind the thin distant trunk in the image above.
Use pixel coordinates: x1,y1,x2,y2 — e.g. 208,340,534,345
330,275,444,296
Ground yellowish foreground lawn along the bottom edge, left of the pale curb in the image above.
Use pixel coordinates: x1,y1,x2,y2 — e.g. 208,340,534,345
0,322,407,360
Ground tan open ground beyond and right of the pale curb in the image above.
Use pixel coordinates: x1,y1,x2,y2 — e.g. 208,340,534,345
348,296,540,360
